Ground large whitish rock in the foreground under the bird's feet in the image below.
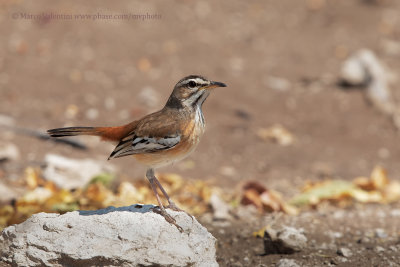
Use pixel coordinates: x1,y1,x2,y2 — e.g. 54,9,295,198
0,204,218,266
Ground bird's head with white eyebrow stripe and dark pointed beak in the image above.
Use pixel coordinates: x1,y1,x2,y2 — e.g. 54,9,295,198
166,75,226,109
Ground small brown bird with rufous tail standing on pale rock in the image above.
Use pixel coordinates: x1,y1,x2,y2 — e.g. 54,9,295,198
47,75,227,231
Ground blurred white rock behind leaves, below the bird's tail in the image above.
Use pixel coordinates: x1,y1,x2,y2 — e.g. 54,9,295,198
43,154,114,189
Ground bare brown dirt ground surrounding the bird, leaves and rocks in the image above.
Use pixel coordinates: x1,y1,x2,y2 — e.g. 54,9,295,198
0,0,400,266
